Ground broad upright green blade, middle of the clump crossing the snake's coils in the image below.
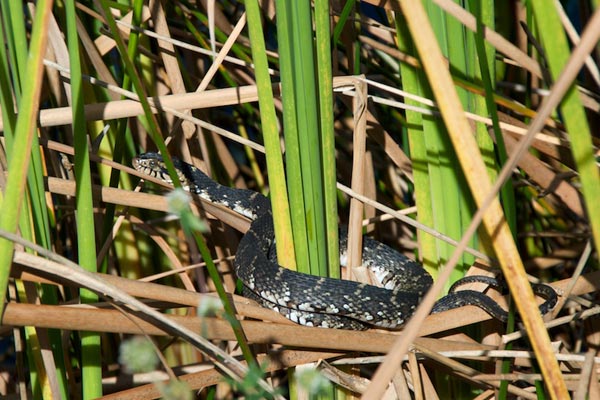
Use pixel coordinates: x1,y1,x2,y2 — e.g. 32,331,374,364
278,1,327,275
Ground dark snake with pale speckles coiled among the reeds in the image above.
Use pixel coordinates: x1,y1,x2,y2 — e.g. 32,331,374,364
132,152,557,330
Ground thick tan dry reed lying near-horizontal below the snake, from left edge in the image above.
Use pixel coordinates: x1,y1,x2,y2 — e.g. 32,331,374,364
2,303,494,353
